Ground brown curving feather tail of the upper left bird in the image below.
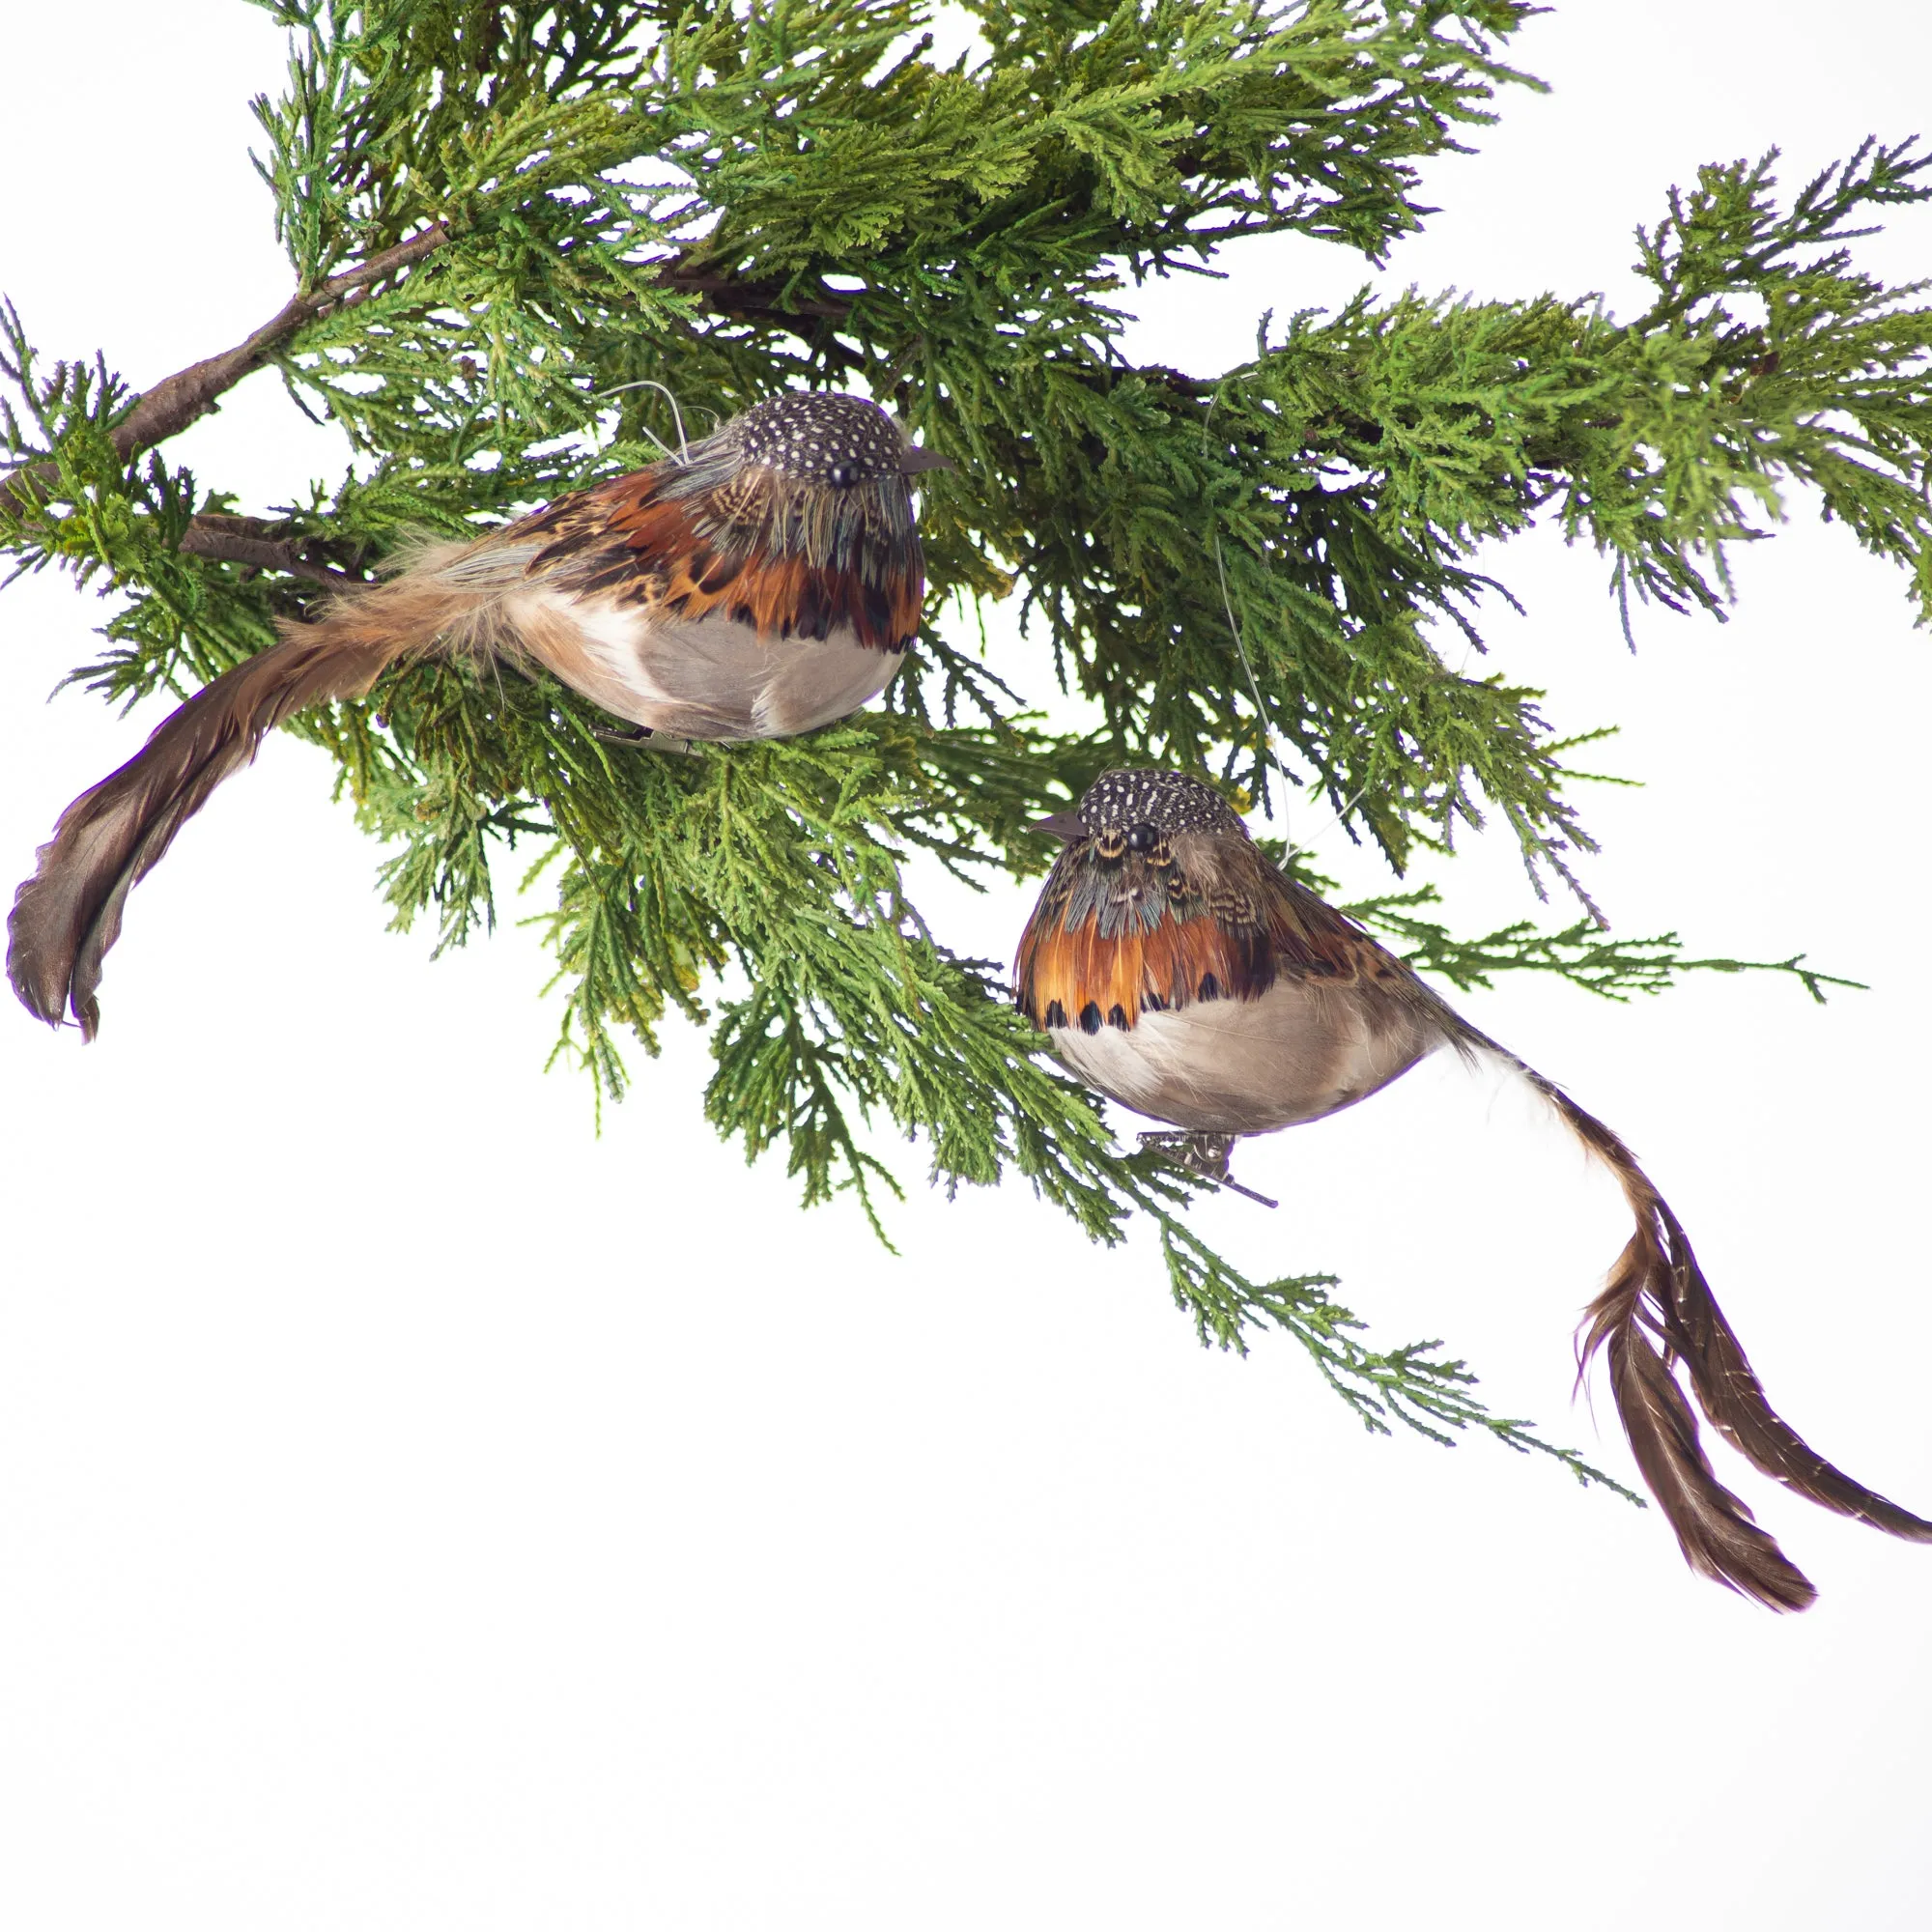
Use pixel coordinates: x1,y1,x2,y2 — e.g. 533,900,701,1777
6,572,475,1039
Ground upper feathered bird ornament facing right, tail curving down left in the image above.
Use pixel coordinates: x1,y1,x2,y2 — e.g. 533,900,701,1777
8,383,952,1039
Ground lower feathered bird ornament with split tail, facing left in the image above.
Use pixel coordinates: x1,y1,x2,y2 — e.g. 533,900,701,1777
1018,771,1932,1609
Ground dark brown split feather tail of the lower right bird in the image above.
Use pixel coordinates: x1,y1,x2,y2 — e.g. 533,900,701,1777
1478,1036,1932,1609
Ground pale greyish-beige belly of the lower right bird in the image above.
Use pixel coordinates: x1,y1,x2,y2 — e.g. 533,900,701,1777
1047,976,1441,1134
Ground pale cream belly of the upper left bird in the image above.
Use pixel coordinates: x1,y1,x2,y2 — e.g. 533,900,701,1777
510,585,904,742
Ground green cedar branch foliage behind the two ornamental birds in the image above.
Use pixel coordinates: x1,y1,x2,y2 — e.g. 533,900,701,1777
0,0,1932,1480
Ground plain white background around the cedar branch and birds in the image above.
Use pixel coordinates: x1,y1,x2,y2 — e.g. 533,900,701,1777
0,0,1932,1932
